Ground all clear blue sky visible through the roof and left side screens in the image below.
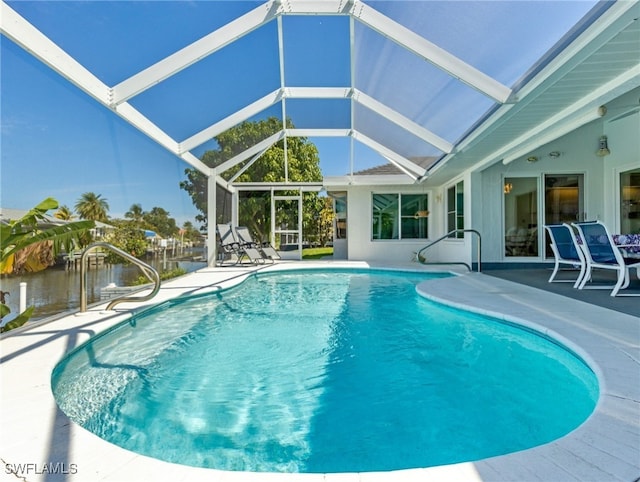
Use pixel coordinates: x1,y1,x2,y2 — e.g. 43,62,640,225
0,1,594,224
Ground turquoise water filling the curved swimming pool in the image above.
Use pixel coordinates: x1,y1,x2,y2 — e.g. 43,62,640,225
52,271,598,473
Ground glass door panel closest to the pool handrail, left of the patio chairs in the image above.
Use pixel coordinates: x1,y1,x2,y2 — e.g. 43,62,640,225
503,177,538,257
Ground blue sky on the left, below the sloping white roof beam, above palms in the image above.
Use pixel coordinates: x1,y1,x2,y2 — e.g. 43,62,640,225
0,34,205,223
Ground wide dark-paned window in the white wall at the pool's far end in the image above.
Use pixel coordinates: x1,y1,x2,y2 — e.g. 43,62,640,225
372,194,429,239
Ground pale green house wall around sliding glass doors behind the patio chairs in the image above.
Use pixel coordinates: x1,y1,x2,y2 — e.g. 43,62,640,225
471,89,640,262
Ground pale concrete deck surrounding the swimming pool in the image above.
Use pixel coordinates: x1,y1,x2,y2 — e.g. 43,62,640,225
0,261,640,482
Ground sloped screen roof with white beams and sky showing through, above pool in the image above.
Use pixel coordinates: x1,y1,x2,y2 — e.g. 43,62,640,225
3,0,596,183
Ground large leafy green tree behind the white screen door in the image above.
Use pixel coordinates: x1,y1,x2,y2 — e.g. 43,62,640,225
180,117,333,249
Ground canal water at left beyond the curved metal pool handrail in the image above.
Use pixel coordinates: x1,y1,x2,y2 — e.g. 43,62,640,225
0,252,205,320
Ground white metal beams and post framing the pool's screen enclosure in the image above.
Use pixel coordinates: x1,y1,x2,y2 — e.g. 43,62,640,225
0,0,512,263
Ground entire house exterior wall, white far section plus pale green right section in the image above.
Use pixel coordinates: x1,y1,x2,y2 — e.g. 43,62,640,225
328,89,640,264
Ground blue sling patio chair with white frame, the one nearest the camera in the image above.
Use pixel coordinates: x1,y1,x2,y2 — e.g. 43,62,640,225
574,221,640,296
